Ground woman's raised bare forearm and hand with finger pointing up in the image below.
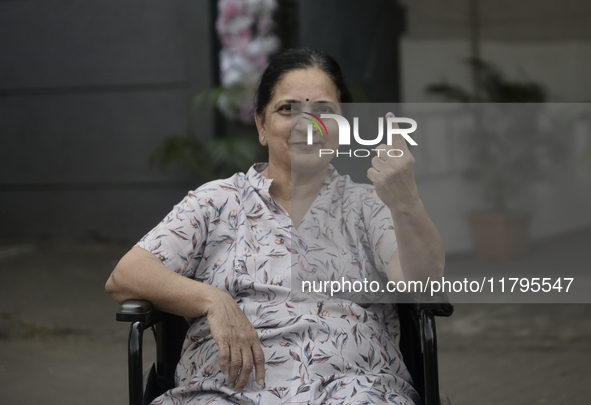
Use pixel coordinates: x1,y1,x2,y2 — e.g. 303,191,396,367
367,113,445,282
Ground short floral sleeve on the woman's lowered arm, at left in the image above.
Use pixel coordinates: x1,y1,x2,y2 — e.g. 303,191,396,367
135,192,207,278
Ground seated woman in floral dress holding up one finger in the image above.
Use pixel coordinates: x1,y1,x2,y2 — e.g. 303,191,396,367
106,50,444,404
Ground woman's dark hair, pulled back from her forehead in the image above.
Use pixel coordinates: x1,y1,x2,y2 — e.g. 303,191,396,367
254,48,353,117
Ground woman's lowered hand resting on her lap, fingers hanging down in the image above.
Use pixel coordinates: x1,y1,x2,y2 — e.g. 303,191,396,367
207,290,265,392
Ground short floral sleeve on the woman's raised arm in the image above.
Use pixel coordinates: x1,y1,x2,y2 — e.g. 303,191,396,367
364,189,398,275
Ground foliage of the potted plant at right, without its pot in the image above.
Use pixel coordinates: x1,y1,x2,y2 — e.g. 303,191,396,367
426,60,565,212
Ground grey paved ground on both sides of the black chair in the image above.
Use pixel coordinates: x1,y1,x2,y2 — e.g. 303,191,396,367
0,230,591,405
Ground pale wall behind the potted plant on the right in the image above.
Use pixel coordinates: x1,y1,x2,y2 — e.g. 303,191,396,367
401,0,591,253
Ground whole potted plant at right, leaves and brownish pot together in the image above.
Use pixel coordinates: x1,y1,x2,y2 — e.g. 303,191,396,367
426,59,563,260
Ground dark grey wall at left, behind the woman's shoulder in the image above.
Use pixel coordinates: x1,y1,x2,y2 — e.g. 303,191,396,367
0,0,212,241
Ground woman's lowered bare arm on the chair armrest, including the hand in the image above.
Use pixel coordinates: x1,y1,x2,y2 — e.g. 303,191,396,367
105,247,265,391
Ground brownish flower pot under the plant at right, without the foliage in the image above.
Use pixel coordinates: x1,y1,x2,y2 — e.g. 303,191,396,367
468,211,531,260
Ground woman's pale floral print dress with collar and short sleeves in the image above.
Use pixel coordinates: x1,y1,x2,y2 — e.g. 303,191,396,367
136,164,420,405
